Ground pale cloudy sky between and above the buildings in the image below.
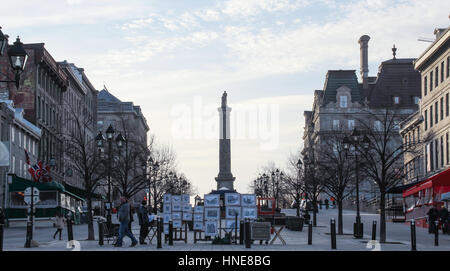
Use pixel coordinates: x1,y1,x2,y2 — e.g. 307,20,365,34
0,0,450,197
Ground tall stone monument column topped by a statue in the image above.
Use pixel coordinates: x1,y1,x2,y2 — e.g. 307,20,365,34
216,91,235,190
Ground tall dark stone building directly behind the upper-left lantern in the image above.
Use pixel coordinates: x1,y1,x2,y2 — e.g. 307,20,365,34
0,43,67,183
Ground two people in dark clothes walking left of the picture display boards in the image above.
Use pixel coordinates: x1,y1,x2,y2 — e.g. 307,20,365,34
114,197,150,247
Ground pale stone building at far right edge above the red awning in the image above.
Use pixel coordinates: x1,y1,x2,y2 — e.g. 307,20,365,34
402,27,450,183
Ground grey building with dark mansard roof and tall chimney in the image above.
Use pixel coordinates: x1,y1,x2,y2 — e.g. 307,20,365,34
302,35,420,206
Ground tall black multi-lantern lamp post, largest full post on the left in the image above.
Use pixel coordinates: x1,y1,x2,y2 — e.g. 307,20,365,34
95,124,125,228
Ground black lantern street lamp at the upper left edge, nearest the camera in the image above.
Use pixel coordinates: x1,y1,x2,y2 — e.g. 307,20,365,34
0,27,28,89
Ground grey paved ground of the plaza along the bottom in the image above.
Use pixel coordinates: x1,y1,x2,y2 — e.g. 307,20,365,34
4,209,450,251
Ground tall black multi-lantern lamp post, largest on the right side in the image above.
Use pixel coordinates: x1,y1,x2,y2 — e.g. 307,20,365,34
342,128,370,239
